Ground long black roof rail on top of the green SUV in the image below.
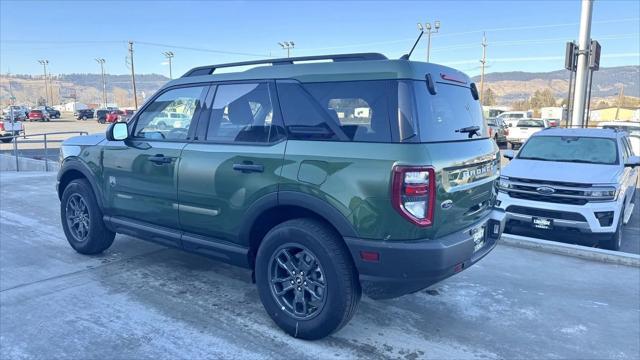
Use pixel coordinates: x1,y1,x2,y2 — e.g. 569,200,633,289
182,53,387,77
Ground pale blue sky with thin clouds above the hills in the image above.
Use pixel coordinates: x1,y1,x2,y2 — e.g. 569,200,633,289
0,0,640,76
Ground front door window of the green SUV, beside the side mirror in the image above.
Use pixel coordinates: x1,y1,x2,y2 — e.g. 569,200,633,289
134,86,206,140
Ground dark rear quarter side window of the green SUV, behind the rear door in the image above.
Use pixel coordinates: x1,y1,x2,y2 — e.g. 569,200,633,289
278,81,398,142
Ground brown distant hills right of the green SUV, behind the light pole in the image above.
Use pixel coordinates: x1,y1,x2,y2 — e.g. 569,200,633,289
473,66,640,105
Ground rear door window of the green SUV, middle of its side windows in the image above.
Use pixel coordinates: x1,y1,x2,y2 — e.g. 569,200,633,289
207,83,275,142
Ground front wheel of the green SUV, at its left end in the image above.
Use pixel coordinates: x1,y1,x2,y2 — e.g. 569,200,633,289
60,179,115,255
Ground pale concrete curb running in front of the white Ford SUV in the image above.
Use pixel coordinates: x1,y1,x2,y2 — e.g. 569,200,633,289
500,234,640,267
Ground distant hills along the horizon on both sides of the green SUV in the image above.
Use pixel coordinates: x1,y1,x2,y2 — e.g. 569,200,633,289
0,66,640,106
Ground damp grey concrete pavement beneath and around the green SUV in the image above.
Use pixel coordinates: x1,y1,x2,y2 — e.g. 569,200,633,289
0,173,640,359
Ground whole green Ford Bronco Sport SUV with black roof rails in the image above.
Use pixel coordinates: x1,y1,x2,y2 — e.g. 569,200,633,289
57,54,504,339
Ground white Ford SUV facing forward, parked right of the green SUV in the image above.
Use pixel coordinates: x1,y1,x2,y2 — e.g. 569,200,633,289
498,128,640,250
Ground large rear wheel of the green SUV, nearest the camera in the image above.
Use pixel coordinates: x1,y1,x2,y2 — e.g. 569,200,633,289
255,219,362,340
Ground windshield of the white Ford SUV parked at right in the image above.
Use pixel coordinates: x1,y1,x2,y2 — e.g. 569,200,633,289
518,136,618,165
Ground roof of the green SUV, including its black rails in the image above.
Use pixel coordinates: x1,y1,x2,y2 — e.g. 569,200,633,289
165,53,471,87
